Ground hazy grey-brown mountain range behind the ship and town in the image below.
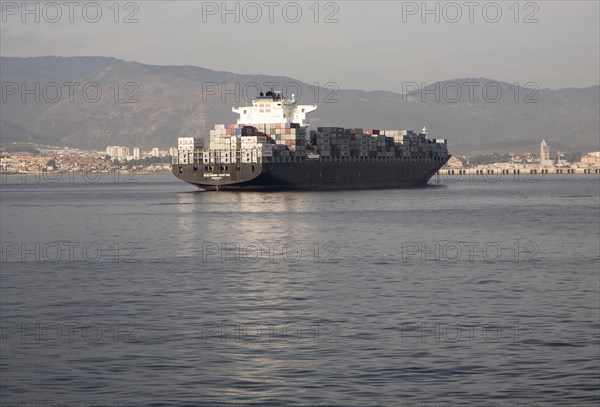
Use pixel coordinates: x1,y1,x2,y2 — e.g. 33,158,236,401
0,56,600,154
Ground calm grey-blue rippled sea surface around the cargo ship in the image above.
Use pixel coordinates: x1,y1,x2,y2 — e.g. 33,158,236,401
0,175,600,406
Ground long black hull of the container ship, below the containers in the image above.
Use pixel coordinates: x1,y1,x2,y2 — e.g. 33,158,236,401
173,158,448,191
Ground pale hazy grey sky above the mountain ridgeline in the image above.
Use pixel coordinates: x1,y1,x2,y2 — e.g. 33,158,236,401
0,0,600,91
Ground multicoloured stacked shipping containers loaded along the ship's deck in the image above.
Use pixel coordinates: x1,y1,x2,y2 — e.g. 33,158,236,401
178,123,448,164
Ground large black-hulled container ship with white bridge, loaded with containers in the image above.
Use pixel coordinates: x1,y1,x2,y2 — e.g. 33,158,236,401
172,91,450,191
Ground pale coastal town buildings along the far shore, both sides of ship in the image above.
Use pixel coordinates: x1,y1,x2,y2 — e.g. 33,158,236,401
0,140,600,175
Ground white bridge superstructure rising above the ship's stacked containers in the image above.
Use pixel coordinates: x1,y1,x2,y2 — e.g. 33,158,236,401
231,91,317,127
